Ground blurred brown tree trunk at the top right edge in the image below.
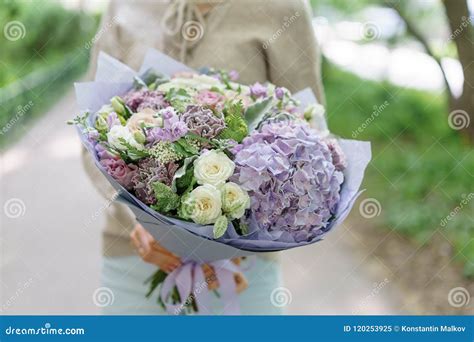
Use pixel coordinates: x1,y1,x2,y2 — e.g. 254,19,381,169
443,0,474,143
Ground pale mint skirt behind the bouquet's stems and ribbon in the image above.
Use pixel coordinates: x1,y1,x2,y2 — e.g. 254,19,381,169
99,256,282,315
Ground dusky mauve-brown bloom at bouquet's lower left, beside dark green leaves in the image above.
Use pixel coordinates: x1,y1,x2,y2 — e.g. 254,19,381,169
132,158,178,205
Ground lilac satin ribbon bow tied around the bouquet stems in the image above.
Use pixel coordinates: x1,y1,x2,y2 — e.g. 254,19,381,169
160,260,241,315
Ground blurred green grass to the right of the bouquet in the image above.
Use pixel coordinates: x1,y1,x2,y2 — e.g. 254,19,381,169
323,60,474,277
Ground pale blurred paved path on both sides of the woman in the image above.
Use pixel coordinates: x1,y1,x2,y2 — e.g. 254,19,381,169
0,93,399,314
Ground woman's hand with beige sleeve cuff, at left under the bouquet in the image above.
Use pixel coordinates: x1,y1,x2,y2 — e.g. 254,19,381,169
130,224,181,273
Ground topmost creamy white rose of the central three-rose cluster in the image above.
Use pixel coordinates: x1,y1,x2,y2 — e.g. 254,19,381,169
194,150,235,186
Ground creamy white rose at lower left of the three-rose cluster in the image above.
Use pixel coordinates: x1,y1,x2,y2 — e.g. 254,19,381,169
181,184,222,224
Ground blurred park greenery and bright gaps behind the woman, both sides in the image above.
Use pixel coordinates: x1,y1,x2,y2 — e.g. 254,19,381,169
0,0,474,277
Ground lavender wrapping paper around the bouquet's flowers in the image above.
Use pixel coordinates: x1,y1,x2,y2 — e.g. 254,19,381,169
75,49,371,262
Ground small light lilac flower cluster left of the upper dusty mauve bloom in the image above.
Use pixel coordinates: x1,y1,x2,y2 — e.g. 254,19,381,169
147,107,188,143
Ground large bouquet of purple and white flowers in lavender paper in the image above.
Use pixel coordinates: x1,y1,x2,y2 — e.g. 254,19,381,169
71,50,370,313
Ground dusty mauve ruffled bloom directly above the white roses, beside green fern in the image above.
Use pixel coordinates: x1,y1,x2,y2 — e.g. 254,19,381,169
181,106,225,139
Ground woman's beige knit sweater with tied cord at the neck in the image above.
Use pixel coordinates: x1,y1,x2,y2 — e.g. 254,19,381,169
83,0,324,256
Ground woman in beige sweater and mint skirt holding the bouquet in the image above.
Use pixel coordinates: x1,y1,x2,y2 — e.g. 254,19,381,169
84,0,324,314
